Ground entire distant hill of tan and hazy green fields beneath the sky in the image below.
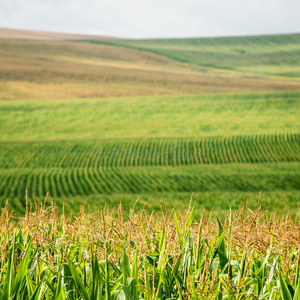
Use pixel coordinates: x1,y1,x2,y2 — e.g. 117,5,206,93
0,28,300,100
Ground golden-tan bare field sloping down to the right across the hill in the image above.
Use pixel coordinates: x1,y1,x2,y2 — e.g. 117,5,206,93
0,39,300,100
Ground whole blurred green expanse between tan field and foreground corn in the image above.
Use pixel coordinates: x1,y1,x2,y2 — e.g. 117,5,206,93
0,92,300,216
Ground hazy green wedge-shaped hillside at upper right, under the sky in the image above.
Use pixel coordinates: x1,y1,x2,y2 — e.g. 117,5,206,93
94,34,300,77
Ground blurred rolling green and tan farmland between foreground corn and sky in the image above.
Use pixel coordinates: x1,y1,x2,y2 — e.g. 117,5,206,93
0,30,300,215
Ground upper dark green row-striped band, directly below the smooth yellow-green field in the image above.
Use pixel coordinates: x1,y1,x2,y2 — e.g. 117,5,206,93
0,133,300,169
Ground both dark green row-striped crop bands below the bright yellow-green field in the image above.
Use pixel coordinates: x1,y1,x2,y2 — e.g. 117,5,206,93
0,133,300,211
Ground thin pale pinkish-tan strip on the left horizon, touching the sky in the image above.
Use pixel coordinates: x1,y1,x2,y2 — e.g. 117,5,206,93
0,28,111,41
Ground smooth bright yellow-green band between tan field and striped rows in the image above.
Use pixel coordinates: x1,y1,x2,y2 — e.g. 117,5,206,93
0,92,300,141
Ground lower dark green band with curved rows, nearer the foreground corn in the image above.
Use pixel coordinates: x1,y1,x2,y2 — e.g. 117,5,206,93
0,163,300,210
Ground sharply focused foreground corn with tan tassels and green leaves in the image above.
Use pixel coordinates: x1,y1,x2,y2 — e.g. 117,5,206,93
0,199,300,300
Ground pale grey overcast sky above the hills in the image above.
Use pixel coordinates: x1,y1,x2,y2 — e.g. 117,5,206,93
0,0,300,38
